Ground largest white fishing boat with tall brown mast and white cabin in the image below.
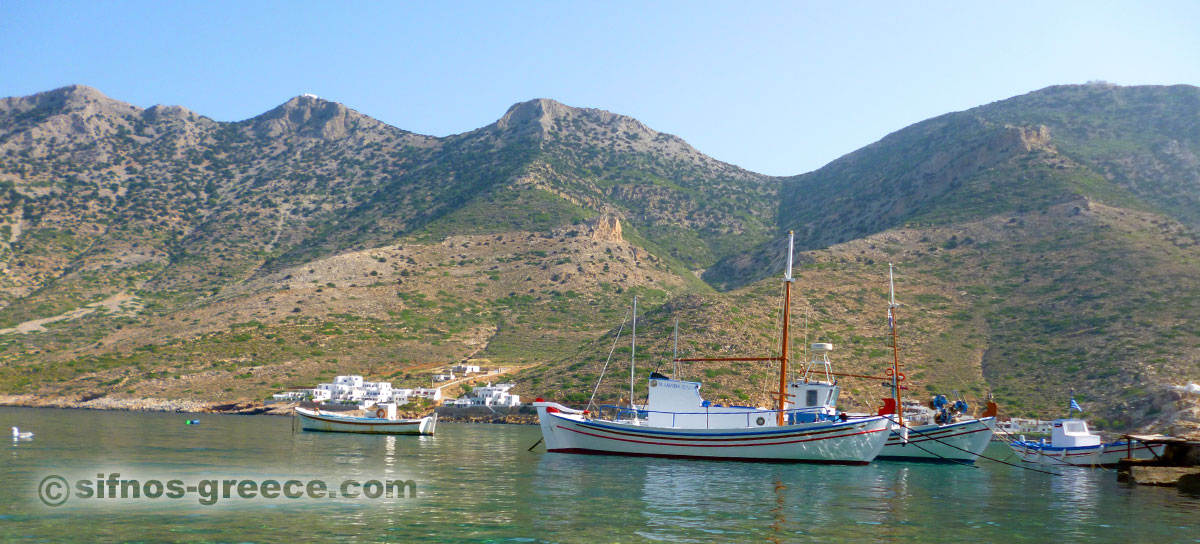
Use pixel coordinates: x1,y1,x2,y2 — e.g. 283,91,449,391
534,230,892,465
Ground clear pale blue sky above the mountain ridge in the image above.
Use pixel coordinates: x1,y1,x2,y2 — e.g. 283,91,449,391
0,0,1200,175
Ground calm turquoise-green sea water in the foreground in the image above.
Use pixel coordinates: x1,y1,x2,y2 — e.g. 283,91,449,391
0,408,1200,543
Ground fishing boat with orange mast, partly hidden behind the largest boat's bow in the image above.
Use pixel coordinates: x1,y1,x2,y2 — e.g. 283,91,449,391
878,263,997,462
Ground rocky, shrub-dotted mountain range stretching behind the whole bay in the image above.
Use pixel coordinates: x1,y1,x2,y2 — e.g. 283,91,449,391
0,85,1200,426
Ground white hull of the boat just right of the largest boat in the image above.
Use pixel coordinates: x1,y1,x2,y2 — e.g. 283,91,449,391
880,418,996,462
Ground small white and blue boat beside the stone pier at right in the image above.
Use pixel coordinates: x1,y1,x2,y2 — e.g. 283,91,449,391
1008,399,1165,467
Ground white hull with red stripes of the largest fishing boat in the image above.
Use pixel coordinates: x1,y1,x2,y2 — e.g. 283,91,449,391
534,402,890,465
